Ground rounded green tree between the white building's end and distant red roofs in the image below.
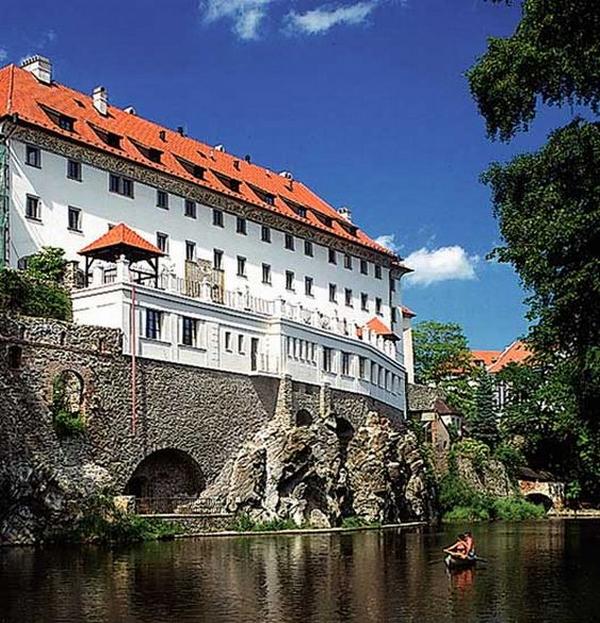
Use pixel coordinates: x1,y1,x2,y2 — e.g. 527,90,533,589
413,320,471,384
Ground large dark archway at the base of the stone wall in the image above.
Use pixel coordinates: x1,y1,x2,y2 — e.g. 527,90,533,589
125,448,205,513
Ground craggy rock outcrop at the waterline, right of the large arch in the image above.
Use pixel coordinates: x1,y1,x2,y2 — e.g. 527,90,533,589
189,411,433,527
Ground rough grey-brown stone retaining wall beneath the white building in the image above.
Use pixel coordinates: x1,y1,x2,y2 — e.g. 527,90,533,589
0,316,429,543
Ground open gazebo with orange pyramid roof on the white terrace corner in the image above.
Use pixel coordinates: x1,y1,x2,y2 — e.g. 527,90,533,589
79,223,165,287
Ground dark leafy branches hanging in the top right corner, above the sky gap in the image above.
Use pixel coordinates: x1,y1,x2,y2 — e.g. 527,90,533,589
467,0,600,140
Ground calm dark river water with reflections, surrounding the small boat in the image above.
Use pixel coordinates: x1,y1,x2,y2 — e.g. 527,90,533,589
0,520,600,623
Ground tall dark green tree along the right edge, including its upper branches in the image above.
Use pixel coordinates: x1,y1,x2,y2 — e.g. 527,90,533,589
468,0,600,497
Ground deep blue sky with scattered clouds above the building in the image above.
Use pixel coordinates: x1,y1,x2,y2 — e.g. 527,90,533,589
0,0,570,348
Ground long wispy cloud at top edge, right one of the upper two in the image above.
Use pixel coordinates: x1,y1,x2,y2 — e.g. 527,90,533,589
285,0,379,35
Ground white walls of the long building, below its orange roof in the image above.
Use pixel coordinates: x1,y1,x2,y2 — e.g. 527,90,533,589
1,94,412,410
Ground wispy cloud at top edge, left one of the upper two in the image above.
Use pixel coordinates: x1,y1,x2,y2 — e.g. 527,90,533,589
199,0,276,41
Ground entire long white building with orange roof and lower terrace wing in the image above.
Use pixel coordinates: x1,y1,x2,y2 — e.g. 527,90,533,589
0,57,412,410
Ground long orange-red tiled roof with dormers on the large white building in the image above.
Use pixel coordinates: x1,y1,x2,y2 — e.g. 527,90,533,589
0,65,399,264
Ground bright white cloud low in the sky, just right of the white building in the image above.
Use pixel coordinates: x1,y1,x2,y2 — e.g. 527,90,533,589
403,245,479,286
